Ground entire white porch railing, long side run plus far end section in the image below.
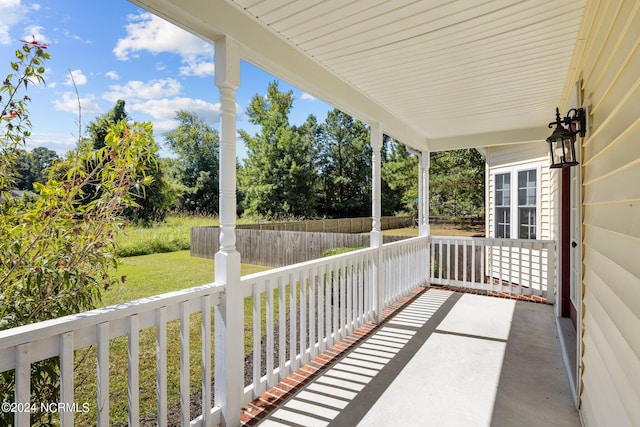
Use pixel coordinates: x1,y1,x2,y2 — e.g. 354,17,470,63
0,237,555,426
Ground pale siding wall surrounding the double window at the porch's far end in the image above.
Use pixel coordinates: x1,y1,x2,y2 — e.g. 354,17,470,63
486,142,554,291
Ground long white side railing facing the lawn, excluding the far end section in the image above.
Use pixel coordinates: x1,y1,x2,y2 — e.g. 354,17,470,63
0,237,428,426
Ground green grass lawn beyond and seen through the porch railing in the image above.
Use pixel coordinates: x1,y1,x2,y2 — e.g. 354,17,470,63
75,217,477,425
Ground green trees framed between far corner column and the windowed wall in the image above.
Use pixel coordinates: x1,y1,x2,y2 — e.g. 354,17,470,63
429,148,485,216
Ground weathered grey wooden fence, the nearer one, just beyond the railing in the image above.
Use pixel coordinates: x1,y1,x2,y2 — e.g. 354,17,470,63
191,227,407,267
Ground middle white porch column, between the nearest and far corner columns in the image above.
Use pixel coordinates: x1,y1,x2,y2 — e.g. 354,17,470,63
371,123,384,323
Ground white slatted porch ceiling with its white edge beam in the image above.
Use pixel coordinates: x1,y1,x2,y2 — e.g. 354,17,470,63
126,0,584,150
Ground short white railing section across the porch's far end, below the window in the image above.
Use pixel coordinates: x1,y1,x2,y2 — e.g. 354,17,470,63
429,236,556,304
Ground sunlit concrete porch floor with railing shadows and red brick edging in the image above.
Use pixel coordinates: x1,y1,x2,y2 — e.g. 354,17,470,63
243,288,580,427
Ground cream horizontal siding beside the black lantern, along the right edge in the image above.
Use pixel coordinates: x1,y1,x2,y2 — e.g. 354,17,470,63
572,0,640,426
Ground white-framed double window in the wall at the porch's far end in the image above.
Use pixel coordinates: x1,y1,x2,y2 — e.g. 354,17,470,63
494,169,538,239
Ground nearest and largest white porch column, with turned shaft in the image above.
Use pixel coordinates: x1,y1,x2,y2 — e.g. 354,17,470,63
216,37,244,426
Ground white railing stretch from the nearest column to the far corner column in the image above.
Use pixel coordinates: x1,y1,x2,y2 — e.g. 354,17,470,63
242,237,428,402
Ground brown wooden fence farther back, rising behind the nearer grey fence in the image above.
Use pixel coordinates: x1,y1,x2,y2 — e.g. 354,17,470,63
236,216,415,233
